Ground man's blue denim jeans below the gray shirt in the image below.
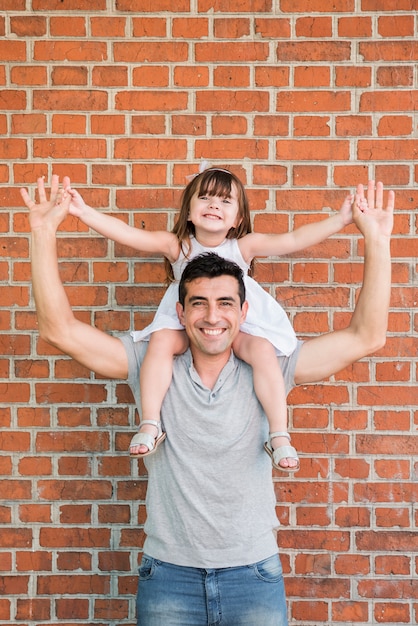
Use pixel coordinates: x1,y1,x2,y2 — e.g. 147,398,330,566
137,554,287,626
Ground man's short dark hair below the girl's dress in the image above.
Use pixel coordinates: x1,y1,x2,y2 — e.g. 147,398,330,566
179,252,245,307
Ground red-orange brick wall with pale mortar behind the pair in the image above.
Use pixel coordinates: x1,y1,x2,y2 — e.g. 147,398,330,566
0,0,418,626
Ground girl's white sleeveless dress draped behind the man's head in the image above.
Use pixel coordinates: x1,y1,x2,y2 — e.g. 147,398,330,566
131,237,297,356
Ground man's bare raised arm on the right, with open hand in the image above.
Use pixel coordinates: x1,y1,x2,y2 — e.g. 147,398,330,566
295,181,395,384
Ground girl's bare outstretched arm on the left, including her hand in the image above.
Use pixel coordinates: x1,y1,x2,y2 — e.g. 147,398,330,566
63,176,179,262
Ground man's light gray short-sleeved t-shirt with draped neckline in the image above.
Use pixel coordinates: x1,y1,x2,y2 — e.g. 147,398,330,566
121,335,301,568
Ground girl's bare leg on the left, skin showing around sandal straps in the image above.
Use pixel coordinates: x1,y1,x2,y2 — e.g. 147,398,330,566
129,330,189,455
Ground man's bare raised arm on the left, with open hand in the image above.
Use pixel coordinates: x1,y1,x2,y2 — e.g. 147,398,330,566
21,176,128,378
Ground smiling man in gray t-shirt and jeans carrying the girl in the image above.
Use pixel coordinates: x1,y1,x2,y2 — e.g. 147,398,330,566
22,177,394,626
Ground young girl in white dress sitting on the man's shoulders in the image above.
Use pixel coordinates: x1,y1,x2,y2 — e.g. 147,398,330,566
66,168,352,472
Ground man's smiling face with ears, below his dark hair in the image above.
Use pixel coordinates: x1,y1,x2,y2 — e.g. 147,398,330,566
177,276,248,356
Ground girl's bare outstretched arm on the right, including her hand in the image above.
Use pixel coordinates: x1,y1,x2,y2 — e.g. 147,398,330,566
239,189,354,262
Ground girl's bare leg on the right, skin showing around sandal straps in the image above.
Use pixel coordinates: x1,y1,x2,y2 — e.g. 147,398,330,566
233,332,298,469
